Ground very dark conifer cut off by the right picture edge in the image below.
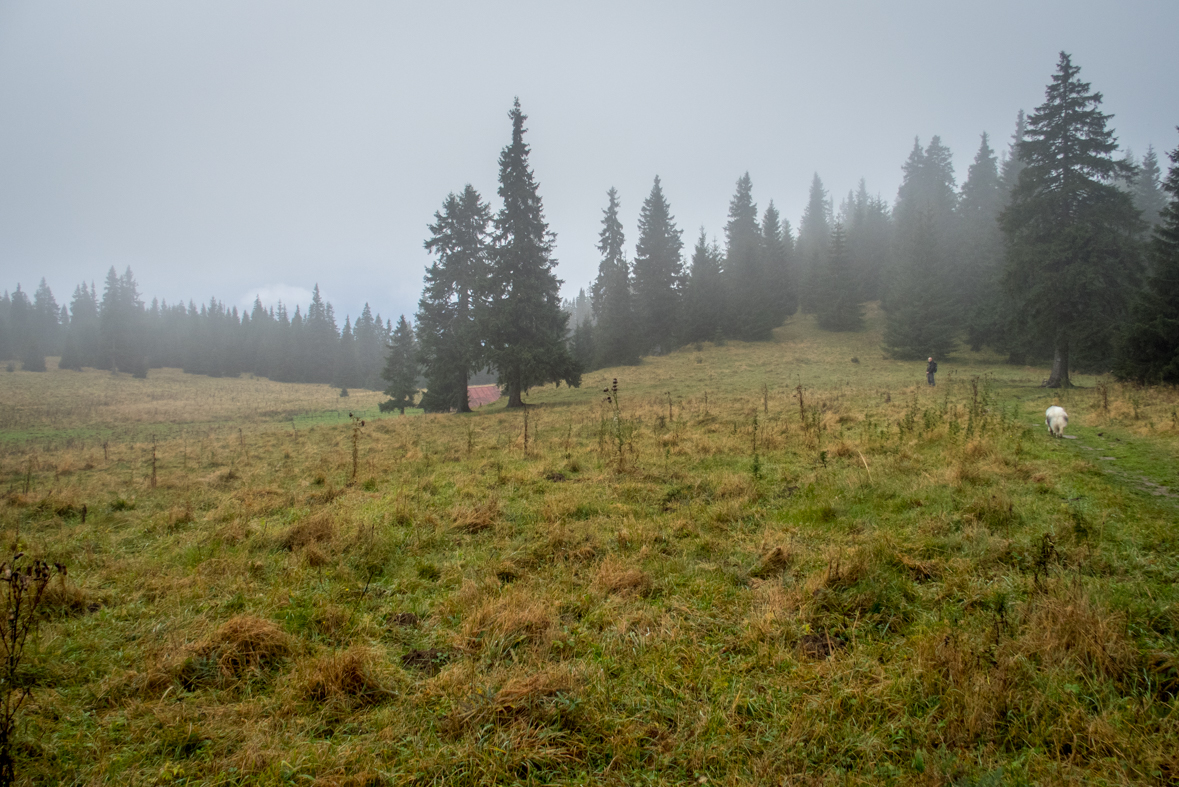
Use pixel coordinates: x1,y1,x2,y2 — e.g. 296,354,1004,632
1115,136,1179,385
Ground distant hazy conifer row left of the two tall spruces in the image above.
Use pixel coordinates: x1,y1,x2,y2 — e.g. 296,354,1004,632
0,267,393,390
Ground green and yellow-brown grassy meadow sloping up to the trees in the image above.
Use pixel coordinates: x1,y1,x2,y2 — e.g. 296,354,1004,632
0,303,1179,786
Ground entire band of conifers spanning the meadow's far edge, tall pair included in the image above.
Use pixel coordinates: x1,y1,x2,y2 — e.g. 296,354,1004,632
0,53,1179,395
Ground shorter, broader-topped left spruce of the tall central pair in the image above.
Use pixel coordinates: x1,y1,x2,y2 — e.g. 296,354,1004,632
417,184,492,412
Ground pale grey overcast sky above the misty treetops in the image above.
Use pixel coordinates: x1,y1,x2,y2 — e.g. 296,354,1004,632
0,0,1179,324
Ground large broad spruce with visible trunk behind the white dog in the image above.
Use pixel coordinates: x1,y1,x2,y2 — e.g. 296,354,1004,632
1001,52,1141,388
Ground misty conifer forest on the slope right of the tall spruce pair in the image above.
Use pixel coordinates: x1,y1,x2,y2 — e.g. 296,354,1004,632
554,53,1179,386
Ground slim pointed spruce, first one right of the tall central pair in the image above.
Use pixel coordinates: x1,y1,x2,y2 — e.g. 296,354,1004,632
587,189,640,369
